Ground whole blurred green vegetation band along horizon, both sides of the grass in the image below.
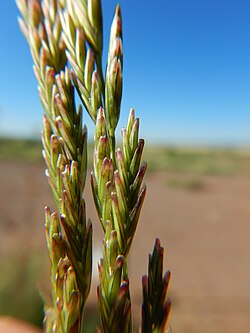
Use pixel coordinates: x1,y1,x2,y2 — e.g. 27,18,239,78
0,139,250,176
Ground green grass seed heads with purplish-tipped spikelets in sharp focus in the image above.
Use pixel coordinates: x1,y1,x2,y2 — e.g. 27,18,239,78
17,0,170,333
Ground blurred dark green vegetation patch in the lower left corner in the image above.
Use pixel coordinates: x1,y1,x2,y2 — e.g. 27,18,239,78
0,249,44,326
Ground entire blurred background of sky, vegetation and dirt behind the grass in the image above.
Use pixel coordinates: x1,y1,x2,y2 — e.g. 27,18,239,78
0,0,250,333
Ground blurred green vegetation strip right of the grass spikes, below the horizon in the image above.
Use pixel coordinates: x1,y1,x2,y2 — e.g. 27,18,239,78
145,146,250,176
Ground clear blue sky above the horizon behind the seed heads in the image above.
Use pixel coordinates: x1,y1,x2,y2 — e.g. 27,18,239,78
0,0,250,145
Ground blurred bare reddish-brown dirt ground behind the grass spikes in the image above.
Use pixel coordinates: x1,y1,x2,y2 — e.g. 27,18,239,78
0,161,250,333
